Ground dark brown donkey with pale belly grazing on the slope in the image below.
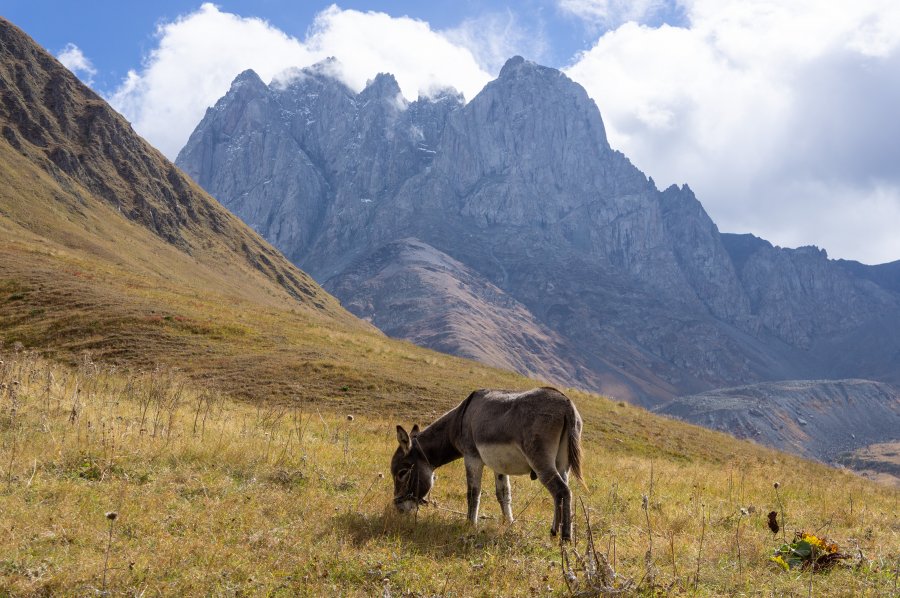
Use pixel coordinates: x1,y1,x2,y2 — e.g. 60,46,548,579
391,388,582,540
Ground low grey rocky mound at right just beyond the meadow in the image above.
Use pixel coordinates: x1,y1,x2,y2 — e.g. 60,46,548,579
656,380,900,463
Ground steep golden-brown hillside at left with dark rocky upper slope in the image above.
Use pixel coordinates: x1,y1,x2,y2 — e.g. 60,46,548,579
0,19,535,416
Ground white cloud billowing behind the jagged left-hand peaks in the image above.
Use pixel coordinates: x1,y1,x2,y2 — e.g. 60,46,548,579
109,3,491,159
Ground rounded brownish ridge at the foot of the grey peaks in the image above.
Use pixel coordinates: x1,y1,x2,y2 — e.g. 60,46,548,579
328,239,600,386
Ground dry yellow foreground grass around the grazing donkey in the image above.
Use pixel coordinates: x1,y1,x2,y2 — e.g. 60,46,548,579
0,347,900,596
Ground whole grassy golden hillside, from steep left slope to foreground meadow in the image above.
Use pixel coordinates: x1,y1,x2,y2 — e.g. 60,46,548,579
0,26,900,596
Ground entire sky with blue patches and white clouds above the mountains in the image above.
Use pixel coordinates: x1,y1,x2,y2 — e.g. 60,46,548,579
7,0,900,264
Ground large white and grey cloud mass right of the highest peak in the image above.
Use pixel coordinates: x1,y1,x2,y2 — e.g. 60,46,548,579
566,0,900,262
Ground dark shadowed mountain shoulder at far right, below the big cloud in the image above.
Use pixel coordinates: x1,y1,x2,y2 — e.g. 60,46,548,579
722,234,900,385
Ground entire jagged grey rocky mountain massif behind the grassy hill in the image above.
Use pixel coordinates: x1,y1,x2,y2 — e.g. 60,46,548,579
177,57,900,404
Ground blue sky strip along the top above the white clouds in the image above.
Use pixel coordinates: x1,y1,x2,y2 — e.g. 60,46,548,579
3,0,683,90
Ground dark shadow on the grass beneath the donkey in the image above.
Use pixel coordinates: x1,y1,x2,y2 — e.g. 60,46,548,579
334,511,521,556
